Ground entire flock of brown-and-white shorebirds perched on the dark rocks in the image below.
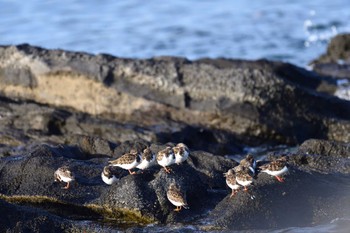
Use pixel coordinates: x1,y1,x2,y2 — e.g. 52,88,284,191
54,143,288,211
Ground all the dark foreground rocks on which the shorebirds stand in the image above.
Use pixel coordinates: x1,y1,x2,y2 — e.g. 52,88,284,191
0,139,350,231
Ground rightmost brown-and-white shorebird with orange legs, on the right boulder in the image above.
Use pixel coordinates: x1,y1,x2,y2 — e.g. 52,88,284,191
260,156,288,182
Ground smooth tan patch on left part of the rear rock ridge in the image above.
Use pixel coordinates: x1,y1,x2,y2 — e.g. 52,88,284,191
0,72,152,115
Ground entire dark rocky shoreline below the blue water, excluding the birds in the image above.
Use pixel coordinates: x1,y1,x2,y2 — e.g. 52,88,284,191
0,34,350,232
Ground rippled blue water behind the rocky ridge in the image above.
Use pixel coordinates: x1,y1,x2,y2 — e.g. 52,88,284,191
0,0,350,66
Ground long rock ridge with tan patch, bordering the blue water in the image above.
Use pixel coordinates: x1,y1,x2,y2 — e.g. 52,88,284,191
0,45,350,146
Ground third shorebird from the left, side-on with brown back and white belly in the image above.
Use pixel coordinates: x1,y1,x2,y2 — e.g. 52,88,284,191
109,150,141,175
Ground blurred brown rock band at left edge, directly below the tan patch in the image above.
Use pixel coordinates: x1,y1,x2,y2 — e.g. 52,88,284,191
0,97,156,157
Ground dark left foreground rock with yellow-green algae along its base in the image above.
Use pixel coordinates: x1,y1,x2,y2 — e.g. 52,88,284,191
0,142,234,228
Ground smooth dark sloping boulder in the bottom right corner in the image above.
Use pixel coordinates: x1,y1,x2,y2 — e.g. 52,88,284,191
206,140,350,230
